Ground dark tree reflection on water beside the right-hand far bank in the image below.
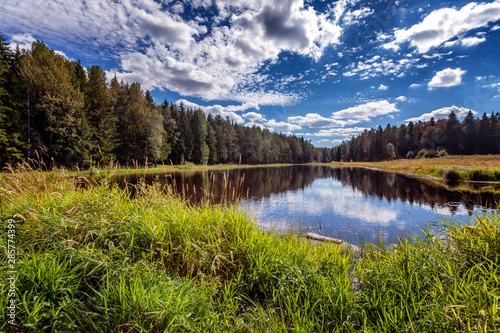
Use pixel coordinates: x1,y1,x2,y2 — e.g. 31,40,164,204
334,168,498,214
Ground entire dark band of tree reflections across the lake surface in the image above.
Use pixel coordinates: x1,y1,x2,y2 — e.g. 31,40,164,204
114,165,499,214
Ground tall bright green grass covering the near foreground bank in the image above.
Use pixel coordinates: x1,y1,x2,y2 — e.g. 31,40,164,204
0,165,500,332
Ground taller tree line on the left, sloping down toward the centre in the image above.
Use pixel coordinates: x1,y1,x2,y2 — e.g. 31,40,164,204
0,35,323,167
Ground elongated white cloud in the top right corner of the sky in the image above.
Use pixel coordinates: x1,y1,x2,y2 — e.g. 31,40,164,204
384,1,500,53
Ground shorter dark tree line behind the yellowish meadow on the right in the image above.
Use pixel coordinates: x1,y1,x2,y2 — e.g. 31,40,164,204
332,111,500,161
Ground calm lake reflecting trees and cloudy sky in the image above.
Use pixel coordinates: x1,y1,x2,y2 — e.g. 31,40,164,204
114,165,500,244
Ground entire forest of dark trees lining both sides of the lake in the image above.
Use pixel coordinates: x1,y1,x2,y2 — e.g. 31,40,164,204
0,34,500,168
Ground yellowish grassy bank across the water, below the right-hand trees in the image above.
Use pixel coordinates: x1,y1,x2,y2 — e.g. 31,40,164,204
331,155,500,182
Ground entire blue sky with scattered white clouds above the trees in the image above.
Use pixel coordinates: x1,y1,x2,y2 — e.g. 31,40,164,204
0,0,500,147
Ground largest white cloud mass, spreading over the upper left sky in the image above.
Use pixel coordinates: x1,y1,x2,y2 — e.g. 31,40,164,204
0,0,358,105
